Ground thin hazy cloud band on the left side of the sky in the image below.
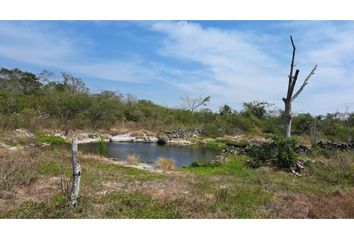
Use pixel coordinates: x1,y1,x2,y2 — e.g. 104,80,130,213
0,22,157,82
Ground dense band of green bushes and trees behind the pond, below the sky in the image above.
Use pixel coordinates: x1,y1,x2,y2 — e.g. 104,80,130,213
0,68,354,141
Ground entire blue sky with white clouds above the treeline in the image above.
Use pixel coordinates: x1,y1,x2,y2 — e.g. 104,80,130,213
0,21,354,114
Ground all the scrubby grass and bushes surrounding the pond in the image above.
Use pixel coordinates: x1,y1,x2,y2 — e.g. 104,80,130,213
0,68,354,218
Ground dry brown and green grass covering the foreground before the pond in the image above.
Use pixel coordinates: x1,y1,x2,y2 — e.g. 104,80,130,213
0,130,354,218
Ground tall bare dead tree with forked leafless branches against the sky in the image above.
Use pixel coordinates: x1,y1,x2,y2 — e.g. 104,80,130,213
283,36,317,137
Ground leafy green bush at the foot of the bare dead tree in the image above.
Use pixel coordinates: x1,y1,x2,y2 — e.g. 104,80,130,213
249,137,297,169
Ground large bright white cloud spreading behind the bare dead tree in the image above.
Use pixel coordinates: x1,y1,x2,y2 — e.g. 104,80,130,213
152,22,354,113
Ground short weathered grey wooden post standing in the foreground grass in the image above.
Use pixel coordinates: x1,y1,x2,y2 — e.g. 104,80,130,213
71,137,81,207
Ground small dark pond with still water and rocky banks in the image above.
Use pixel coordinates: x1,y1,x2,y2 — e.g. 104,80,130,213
79,143,218,167
